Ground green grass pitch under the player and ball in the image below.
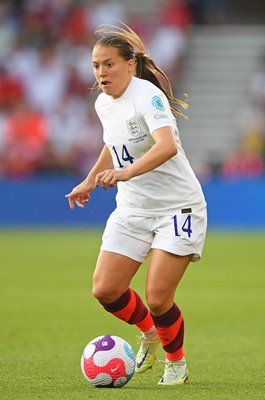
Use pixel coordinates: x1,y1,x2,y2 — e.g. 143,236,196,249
0,230,265,400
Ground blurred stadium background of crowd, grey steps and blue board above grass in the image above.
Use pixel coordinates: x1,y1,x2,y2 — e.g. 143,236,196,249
0,0,265,229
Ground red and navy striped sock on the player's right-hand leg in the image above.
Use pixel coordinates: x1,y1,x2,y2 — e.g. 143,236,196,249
152,304,184,361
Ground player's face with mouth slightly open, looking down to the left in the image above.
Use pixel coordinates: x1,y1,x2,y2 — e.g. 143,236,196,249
92,46,134,98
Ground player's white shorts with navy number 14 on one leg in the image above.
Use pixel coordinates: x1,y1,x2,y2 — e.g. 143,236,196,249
101,207,207,263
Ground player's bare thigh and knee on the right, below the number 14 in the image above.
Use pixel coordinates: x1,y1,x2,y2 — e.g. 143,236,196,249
146,249,192,315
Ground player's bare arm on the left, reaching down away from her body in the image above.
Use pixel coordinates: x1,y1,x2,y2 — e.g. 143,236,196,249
65,145,114,209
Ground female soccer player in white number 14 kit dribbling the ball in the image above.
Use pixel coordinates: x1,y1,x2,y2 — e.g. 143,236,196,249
66,25,206,385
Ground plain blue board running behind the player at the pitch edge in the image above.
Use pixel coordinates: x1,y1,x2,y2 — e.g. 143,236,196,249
0,175,265,229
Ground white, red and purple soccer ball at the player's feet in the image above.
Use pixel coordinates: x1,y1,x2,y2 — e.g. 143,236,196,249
81,335,135,388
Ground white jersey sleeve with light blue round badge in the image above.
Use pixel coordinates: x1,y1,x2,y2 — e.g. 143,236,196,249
141,88,176,133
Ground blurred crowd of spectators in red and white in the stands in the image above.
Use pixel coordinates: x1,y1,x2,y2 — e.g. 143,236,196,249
0,0,265,178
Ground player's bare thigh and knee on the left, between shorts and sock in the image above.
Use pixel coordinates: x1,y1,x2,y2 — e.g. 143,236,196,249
93,250,141,303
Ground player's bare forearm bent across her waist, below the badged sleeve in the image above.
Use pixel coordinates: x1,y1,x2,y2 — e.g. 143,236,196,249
96,126,178,188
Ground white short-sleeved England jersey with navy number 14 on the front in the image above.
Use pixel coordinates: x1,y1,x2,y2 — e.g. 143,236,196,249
95,77,206,216
